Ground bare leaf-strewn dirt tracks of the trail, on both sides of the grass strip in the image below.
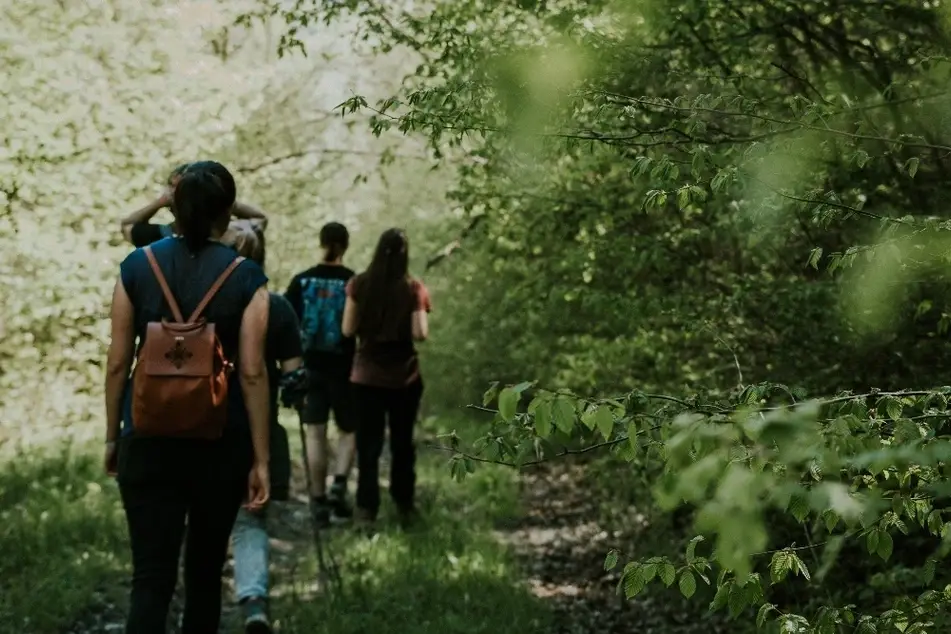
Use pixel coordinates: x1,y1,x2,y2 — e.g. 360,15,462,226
62,450,732,634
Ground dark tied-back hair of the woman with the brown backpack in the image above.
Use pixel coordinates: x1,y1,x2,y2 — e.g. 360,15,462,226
174,161,236,253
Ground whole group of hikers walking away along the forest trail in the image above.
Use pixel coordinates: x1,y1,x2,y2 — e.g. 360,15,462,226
105,161,431,634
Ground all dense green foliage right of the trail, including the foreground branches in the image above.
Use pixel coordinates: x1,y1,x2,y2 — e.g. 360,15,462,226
258,0,951,632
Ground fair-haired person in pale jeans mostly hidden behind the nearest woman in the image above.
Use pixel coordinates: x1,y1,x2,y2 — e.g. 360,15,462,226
222,220,304,634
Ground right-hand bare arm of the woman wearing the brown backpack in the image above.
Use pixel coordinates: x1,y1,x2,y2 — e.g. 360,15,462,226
238,286,271,465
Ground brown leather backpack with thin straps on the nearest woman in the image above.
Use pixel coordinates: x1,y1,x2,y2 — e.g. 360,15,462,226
132,247,244,440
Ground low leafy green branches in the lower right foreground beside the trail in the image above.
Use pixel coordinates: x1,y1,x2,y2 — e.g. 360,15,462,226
446,383,951,634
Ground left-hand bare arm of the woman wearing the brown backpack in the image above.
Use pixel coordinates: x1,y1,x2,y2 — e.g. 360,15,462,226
105,279,135,442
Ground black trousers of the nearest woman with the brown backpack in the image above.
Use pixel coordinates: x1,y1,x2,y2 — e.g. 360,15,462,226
119,439,248,634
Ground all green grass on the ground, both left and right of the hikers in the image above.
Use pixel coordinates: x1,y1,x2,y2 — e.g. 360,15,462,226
0,418,549,634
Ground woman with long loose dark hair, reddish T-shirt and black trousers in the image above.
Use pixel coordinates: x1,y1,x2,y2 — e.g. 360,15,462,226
343,229,432,524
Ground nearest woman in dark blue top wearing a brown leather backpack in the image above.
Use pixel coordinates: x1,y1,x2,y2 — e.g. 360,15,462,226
105,161,270,634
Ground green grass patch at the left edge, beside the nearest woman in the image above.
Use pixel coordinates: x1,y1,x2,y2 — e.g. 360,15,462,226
0,442,128,634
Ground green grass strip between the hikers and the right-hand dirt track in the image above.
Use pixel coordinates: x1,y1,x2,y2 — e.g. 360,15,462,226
274,418,550,634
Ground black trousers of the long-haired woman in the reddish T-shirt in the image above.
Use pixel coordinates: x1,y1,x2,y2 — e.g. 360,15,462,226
354,380,423,518
